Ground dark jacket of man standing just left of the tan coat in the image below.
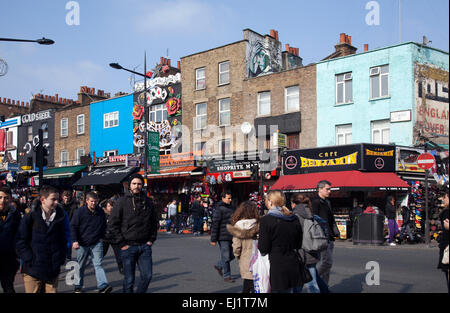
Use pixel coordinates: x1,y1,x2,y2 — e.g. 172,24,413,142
211,201,234,242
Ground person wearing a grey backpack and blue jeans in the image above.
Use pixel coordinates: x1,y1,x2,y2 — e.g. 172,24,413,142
291,193,329,293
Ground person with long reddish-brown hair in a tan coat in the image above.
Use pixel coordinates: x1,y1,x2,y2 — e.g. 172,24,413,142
227,201,259,293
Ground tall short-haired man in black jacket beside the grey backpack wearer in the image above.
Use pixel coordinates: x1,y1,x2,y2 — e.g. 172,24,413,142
312,180,339,285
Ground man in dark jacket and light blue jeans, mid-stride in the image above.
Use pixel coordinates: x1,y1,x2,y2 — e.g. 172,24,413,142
70,192,112,293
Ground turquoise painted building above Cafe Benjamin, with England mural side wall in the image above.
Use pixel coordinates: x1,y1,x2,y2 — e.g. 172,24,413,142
316,42,449,147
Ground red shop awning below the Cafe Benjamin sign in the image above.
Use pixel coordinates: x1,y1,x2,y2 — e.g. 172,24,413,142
270,171,409,192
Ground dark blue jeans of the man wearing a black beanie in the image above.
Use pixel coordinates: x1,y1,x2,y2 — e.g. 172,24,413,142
120,244,153,293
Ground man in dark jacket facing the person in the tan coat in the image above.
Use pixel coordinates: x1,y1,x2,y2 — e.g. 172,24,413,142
211,192,234,283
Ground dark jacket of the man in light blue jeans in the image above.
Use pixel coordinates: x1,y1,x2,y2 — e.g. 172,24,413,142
70,205,106,247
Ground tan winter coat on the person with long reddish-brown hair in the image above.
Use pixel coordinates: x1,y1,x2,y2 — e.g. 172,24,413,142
227,219,259,280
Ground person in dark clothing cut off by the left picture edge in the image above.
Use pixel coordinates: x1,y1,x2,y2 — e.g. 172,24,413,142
0,187,21,293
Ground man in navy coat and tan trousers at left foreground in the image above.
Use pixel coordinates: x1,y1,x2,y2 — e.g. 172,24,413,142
16,186,68,293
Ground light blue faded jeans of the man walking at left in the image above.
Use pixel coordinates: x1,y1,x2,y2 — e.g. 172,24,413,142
75,241,108,289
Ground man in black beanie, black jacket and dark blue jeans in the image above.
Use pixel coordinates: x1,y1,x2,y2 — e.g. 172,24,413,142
108,174,158,293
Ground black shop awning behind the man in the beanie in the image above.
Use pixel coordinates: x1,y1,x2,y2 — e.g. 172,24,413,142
74,166,139,186
